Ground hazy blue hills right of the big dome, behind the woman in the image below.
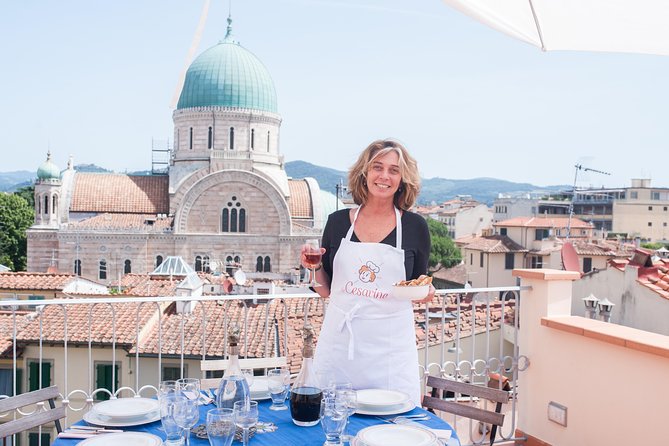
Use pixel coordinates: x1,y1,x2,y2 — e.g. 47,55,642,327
285,161,570,205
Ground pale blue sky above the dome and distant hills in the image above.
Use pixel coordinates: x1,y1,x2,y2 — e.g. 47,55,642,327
0,0,669,187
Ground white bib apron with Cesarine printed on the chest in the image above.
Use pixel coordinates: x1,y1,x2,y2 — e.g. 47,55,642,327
314,208,420,405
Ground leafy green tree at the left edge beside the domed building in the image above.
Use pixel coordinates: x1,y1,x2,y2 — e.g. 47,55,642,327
0,193,35,271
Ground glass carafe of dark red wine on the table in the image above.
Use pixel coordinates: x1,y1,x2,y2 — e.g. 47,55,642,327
290,325,323,426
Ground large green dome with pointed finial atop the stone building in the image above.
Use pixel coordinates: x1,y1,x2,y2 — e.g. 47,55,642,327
177,18,277,113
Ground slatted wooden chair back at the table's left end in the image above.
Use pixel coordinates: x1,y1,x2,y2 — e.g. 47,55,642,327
0,386,67,438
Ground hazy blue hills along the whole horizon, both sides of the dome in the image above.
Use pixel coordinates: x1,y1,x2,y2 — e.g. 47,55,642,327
0,161,571,205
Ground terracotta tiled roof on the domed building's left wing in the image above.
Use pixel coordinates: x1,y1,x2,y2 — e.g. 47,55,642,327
70,172,169,214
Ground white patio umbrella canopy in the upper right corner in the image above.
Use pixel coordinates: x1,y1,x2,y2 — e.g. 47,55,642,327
443,0,669,55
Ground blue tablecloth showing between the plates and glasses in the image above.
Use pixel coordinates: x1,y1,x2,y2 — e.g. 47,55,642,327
52,401,460,446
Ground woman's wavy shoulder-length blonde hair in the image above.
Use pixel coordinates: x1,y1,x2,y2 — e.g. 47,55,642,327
348,139,420,210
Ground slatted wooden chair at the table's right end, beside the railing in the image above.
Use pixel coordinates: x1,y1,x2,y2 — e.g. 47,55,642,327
423,376,509,446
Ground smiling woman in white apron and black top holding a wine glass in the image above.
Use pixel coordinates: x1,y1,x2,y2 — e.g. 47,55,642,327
302,140,435,404
